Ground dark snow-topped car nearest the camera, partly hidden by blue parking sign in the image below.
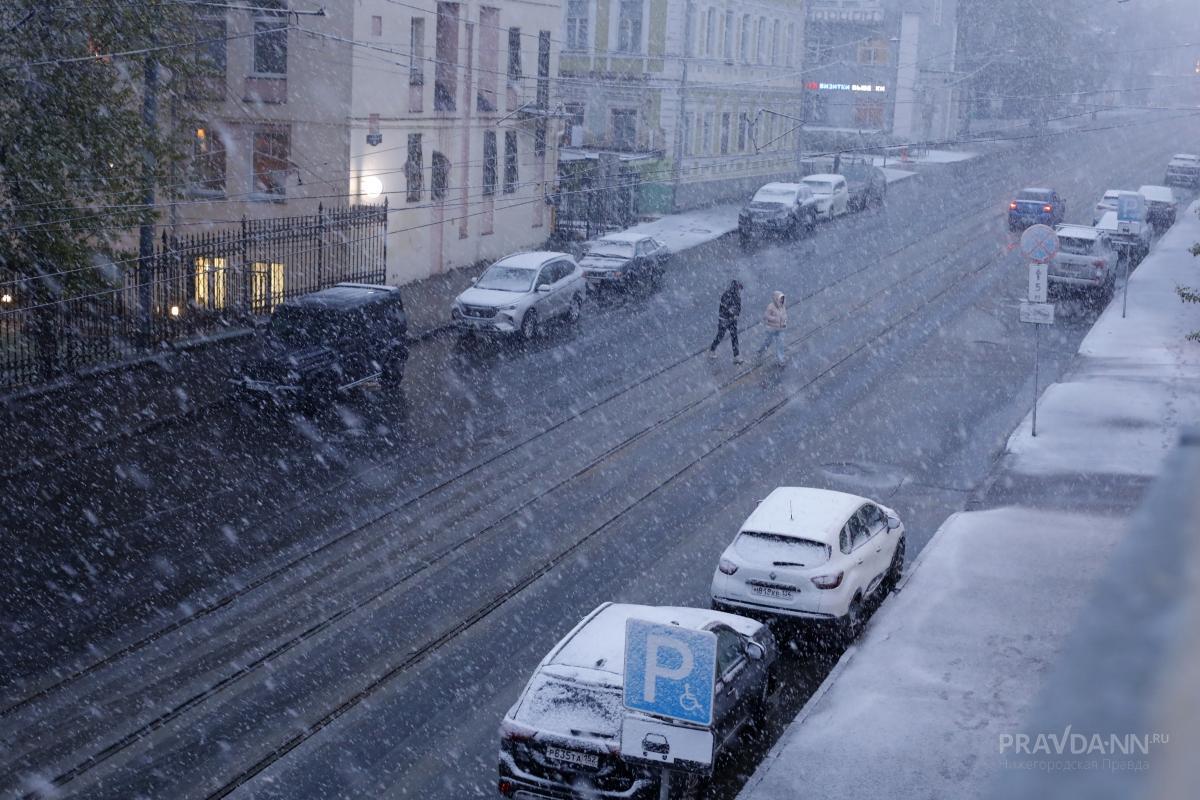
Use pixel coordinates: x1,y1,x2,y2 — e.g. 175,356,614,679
499,603,776,800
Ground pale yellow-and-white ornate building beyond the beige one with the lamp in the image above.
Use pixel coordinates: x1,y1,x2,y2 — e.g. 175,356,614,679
559,0,804,211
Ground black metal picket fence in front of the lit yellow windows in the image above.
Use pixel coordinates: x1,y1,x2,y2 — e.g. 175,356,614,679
0,204,388,390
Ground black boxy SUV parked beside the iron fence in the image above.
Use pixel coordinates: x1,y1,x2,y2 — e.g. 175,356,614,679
233,283,408,410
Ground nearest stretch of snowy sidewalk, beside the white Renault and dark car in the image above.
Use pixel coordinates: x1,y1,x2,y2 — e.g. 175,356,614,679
739,509,1123,800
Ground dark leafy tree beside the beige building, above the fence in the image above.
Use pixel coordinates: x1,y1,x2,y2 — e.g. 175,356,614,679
0,0,211,306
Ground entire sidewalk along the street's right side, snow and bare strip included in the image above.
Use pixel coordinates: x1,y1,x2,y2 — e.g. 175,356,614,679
740,204,1200,800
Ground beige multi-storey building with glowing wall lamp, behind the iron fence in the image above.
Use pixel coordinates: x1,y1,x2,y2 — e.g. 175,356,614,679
173,0,562,284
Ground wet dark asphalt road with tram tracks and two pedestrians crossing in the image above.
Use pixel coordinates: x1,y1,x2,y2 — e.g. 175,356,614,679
0,110,1195,799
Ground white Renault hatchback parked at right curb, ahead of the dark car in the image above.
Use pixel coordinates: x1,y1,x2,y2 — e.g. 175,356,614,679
712,486,905,638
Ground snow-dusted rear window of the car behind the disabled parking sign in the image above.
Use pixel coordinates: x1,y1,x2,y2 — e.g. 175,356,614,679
517,673,625,738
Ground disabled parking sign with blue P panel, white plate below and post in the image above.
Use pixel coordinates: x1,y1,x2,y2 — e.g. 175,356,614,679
620,619,716,800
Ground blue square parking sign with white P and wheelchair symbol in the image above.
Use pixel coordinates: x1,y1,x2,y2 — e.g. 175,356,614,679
625,619,716,727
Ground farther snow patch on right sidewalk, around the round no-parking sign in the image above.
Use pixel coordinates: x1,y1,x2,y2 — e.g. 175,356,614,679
1008,204,1200,476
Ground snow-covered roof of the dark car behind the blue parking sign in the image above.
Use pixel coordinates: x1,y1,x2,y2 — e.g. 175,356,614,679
540,603,762,685
